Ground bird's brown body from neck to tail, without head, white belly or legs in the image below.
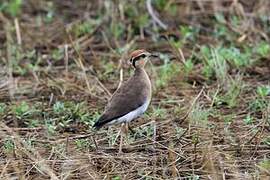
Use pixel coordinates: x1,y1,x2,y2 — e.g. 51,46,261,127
94,68,151,128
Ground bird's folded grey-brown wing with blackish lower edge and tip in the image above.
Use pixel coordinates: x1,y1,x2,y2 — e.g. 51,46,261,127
94,79,147,128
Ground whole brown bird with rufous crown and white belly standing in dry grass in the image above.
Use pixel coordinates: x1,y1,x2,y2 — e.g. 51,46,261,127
93,49,158,153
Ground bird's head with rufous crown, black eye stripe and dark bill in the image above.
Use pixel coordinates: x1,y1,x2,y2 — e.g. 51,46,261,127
129,49,156,68
